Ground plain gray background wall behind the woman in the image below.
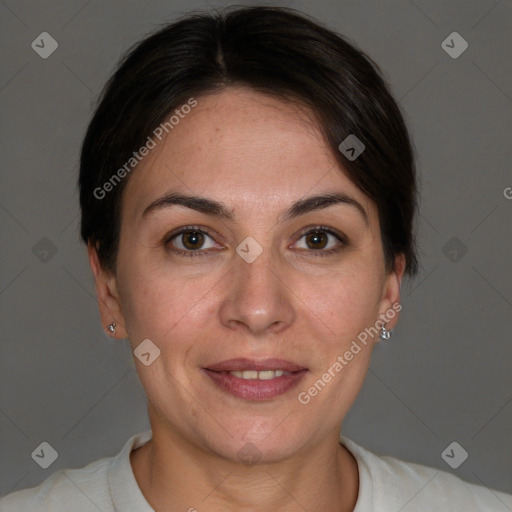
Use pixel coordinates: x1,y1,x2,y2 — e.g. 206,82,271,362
0,0,512,500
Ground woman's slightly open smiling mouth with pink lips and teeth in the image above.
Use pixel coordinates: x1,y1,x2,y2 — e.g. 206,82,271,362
202,358,308,401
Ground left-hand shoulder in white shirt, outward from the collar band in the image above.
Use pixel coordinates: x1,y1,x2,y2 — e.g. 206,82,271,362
0,458,113,512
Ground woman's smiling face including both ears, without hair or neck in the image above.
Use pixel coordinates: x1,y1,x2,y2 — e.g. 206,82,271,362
90,88,403,461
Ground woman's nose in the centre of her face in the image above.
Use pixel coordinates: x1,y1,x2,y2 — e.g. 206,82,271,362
220,246,296,336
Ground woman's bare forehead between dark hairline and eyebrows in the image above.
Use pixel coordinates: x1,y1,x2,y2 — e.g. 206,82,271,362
123,88,372,221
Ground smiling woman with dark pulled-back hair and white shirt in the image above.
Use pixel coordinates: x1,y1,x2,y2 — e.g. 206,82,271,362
0,7,511,512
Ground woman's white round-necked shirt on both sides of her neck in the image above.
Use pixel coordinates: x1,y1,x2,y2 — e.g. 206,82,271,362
0,430,512,512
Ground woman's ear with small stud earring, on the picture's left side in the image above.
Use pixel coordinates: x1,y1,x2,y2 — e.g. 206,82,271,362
87,242,128,339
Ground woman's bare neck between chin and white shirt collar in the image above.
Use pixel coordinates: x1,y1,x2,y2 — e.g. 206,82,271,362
130,422,359,512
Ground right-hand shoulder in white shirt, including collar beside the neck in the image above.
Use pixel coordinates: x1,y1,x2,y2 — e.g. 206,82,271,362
341,436,512,512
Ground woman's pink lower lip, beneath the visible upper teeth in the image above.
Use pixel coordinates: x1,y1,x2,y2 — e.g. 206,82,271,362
203,368,308,401
